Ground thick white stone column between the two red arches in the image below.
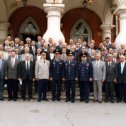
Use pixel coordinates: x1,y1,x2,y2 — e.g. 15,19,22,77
43,3,65,45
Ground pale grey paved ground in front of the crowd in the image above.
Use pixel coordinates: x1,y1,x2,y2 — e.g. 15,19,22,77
0,100,126,126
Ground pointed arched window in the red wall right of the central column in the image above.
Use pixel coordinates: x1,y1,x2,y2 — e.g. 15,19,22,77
70,19,92,44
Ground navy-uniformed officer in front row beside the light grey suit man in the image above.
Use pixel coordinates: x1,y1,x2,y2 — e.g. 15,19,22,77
78,53,93,103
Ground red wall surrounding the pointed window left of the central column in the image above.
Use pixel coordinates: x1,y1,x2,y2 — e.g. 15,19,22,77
9,6,47,37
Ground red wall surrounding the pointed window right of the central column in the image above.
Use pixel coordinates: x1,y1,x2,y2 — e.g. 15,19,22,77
61,8,102,44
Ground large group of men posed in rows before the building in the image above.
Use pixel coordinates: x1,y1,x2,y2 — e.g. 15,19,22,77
0,36,126,103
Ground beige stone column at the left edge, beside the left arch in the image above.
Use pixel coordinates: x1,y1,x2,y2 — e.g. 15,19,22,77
0,23,9,43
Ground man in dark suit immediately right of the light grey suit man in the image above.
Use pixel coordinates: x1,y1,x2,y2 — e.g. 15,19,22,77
105,54,116,103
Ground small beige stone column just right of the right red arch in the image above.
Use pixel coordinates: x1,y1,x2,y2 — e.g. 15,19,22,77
101,24,115,40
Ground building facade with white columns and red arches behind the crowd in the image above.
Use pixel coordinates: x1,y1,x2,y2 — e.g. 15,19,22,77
0,0,126,46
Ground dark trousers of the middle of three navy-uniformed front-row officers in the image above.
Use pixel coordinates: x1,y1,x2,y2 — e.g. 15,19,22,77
66,80,75,100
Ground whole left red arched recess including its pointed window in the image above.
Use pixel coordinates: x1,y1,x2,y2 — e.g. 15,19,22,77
9,6,47,40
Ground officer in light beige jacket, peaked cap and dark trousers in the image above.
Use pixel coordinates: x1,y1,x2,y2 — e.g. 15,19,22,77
35,51,50,102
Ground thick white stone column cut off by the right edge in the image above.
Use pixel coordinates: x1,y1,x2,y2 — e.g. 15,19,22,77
115,6,126,49
